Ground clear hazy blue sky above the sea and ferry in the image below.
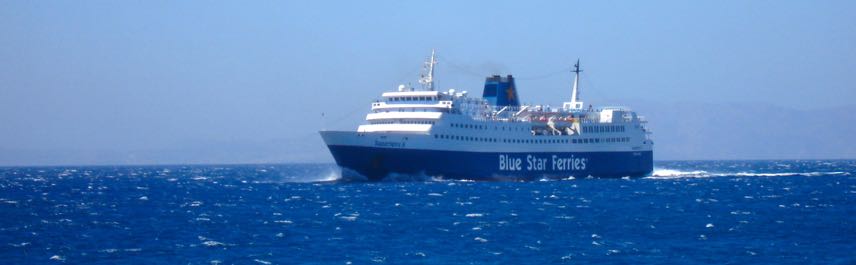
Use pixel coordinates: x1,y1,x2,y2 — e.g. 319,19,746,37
0,1,856,165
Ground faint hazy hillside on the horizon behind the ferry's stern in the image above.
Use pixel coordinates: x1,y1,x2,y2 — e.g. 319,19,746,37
633,102,856,160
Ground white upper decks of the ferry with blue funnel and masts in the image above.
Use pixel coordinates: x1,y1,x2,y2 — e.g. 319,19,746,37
358,50,645,140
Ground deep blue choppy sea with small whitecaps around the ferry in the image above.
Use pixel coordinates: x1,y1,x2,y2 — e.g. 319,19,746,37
0,160,856,264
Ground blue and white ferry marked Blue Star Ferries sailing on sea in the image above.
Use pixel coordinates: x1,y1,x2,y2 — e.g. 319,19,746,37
320,51,654,180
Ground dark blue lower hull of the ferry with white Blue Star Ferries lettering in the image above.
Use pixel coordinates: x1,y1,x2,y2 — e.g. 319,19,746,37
328,145,654,180
